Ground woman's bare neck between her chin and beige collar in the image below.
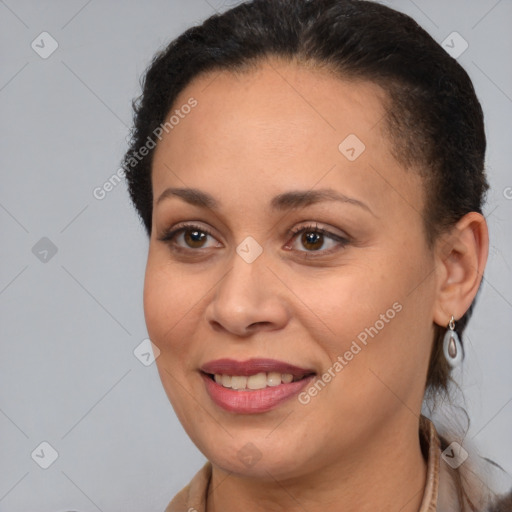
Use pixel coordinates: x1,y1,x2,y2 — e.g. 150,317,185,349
206,420,427,512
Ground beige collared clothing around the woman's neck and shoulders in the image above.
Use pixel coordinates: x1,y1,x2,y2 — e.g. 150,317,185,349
165,416,512,512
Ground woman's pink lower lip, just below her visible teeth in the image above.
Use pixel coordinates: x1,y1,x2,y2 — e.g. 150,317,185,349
201,373,314,414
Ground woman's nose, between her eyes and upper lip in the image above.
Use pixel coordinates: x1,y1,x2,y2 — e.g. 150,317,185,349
205,246,289,337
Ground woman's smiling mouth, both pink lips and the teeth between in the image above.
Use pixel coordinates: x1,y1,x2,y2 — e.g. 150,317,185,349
200,359,316,414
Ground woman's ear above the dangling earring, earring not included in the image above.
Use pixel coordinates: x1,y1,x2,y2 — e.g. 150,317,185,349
434,212,489,327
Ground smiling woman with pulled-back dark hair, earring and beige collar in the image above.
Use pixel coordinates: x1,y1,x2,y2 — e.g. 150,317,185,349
124,0,510,512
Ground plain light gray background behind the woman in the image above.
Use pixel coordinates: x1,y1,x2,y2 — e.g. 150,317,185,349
0,0,512,512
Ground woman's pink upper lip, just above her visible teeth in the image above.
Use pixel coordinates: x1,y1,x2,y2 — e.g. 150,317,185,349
201,358,315,377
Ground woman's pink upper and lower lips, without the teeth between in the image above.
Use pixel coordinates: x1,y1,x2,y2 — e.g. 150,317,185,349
200,359,315,414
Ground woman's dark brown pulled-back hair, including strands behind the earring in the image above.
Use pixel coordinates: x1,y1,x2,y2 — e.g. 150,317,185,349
123,0,488,508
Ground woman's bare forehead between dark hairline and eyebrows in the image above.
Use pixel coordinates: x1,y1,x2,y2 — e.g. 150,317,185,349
153,60,420,217
